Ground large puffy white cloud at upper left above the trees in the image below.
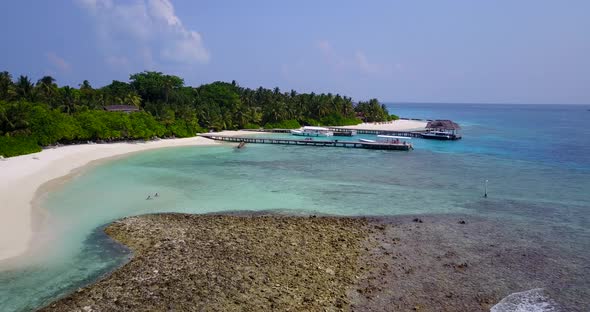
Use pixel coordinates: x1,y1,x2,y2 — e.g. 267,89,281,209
77,0,210,68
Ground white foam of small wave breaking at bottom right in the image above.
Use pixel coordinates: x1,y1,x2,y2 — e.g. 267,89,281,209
490,288,559,312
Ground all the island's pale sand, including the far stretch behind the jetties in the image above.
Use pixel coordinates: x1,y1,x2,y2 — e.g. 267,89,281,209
0,120,425,266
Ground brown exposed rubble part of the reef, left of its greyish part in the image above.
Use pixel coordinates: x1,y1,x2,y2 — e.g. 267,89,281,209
43,214,368,311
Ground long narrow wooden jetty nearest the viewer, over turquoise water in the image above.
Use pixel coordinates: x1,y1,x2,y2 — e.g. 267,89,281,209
200,133,414,151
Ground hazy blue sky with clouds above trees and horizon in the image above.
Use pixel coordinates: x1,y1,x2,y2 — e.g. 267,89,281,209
0,0,590,104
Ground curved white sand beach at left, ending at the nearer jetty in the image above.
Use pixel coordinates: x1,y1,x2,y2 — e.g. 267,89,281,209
0,133,222,261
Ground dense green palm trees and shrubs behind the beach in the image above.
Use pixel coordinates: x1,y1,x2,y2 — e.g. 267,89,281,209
0,72,395,156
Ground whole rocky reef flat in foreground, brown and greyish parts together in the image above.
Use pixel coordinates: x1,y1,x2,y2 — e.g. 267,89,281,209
43,213,590,311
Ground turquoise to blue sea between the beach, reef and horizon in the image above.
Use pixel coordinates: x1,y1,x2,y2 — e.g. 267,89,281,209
0,103,590,311
